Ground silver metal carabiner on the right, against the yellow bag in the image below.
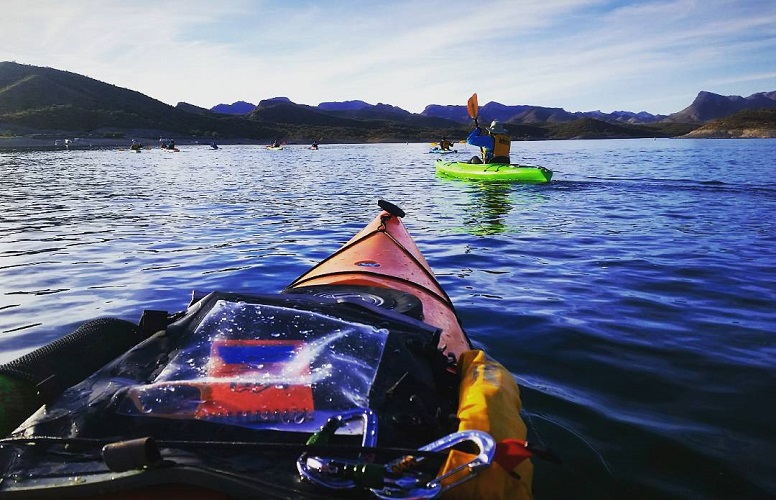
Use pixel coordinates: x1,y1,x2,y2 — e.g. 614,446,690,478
371,430,496,500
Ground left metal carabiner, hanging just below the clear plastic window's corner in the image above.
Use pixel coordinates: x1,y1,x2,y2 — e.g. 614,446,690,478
296,408,377,490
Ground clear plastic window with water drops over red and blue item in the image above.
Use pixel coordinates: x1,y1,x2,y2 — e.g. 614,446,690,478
121,300,388,432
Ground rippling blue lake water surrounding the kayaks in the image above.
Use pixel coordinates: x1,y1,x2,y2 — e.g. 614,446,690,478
0,140,776,498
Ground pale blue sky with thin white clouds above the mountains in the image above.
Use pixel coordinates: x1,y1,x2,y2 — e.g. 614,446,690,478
0,0,776,114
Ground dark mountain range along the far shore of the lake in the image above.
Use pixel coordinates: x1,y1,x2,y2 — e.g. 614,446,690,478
0,62,776,142
